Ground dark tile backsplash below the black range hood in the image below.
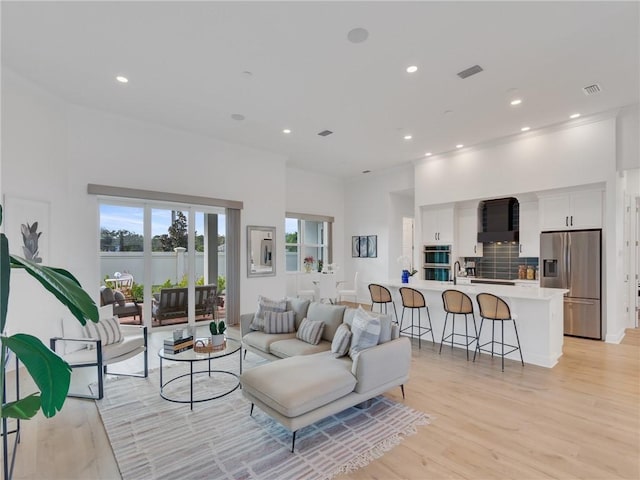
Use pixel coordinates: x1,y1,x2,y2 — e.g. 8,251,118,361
464,243,538,280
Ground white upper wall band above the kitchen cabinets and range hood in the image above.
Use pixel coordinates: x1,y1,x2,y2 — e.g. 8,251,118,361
415,118,616,206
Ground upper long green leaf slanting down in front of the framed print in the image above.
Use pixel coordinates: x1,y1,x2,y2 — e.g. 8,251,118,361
10,255,98,325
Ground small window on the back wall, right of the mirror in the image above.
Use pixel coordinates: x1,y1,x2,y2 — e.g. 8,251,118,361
285,213,333,272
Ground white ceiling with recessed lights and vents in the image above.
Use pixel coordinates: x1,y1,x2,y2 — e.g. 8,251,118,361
1,1,640,176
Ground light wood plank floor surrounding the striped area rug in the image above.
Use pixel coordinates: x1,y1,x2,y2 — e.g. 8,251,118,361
2,322,640,480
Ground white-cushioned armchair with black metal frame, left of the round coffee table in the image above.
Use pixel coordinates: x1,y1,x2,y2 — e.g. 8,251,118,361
50,309,149,400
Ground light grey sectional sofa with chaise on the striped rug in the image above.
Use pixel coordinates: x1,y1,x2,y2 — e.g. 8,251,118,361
240,299,411,451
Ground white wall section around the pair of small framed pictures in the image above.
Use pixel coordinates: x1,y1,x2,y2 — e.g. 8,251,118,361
344,166,413,303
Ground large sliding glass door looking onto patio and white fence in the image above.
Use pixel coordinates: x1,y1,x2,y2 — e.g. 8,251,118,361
100,200,226,327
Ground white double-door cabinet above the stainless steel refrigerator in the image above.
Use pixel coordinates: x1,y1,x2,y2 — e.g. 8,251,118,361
540,190,602,231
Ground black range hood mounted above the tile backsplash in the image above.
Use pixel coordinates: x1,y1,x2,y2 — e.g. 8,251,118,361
478,197,519,243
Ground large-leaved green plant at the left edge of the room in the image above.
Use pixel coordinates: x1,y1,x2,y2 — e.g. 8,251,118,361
0,206,98,420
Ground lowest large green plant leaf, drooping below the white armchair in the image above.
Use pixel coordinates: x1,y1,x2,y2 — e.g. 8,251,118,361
2,333,71,417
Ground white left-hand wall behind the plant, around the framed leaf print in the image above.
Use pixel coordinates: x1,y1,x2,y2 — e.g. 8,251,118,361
0,69,73,345
